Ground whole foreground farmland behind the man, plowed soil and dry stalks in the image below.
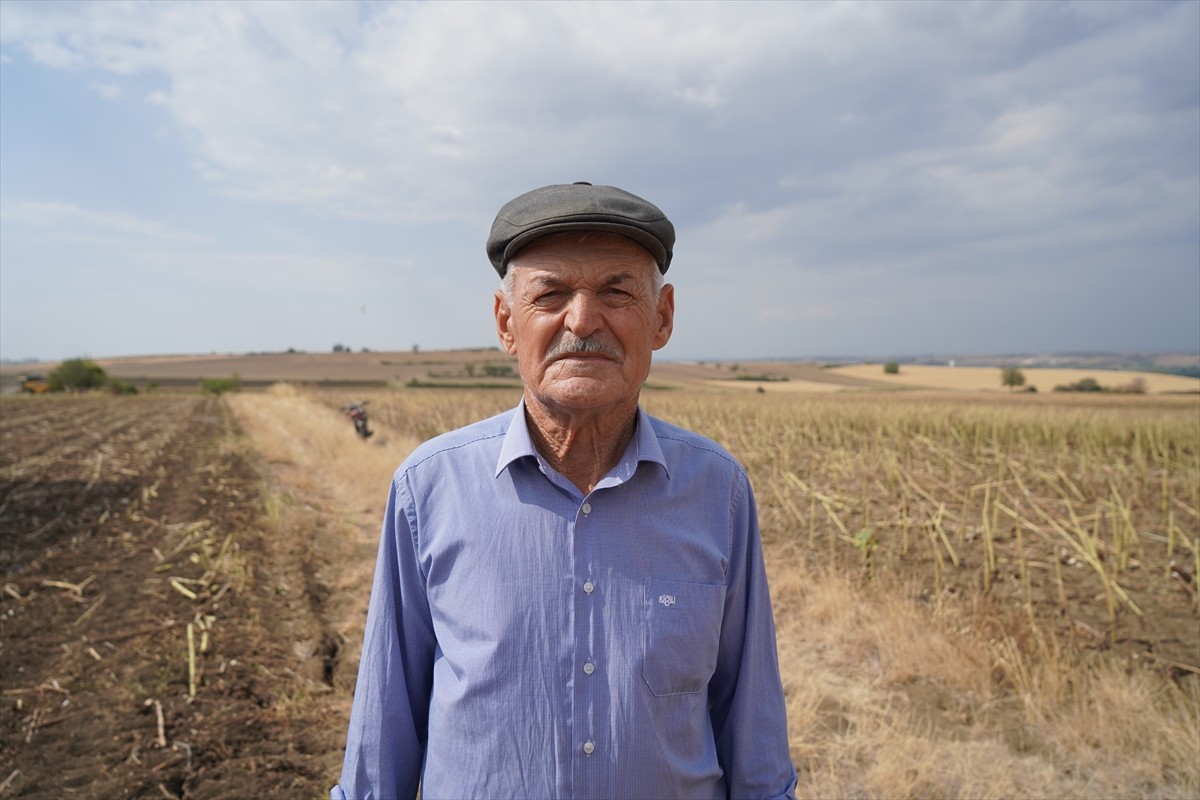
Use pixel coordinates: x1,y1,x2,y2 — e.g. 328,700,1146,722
0,383,1200,798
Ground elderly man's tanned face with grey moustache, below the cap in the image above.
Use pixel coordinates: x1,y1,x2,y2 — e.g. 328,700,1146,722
496,233,674,411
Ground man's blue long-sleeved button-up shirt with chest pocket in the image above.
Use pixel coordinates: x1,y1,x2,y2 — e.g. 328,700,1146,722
331,405,796,800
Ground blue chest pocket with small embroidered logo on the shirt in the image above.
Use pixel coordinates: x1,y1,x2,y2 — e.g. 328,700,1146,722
642,578,725,697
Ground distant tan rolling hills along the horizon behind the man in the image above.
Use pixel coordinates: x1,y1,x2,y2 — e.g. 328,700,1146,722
0,348,1200,393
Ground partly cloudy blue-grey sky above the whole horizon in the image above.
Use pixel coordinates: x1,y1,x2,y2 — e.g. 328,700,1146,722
0,0,1200,360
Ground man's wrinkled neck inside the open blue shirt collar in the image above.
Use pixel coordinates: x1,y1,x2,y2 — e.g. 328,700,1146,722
526,393,637,494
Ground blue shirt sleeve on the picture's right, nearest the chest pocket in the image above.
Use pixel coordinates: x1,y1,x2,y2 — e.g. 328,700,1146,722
709,475,796,800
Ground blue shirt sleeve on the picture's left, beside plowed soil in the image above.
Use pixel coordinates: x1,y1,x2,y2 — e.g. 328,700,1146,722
330,473,437,800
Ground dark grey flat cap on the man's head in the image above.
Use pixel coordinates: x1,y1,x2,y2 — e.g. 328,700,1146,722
487,181,674,278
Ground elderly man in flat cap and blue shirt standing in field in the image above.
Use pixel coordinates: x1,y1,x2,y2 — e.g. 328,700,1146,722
332,184,796,800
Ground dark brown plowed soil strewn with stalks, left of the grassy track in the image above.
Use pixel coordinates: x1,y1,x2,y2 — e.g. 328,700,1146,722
0,396,353,798
